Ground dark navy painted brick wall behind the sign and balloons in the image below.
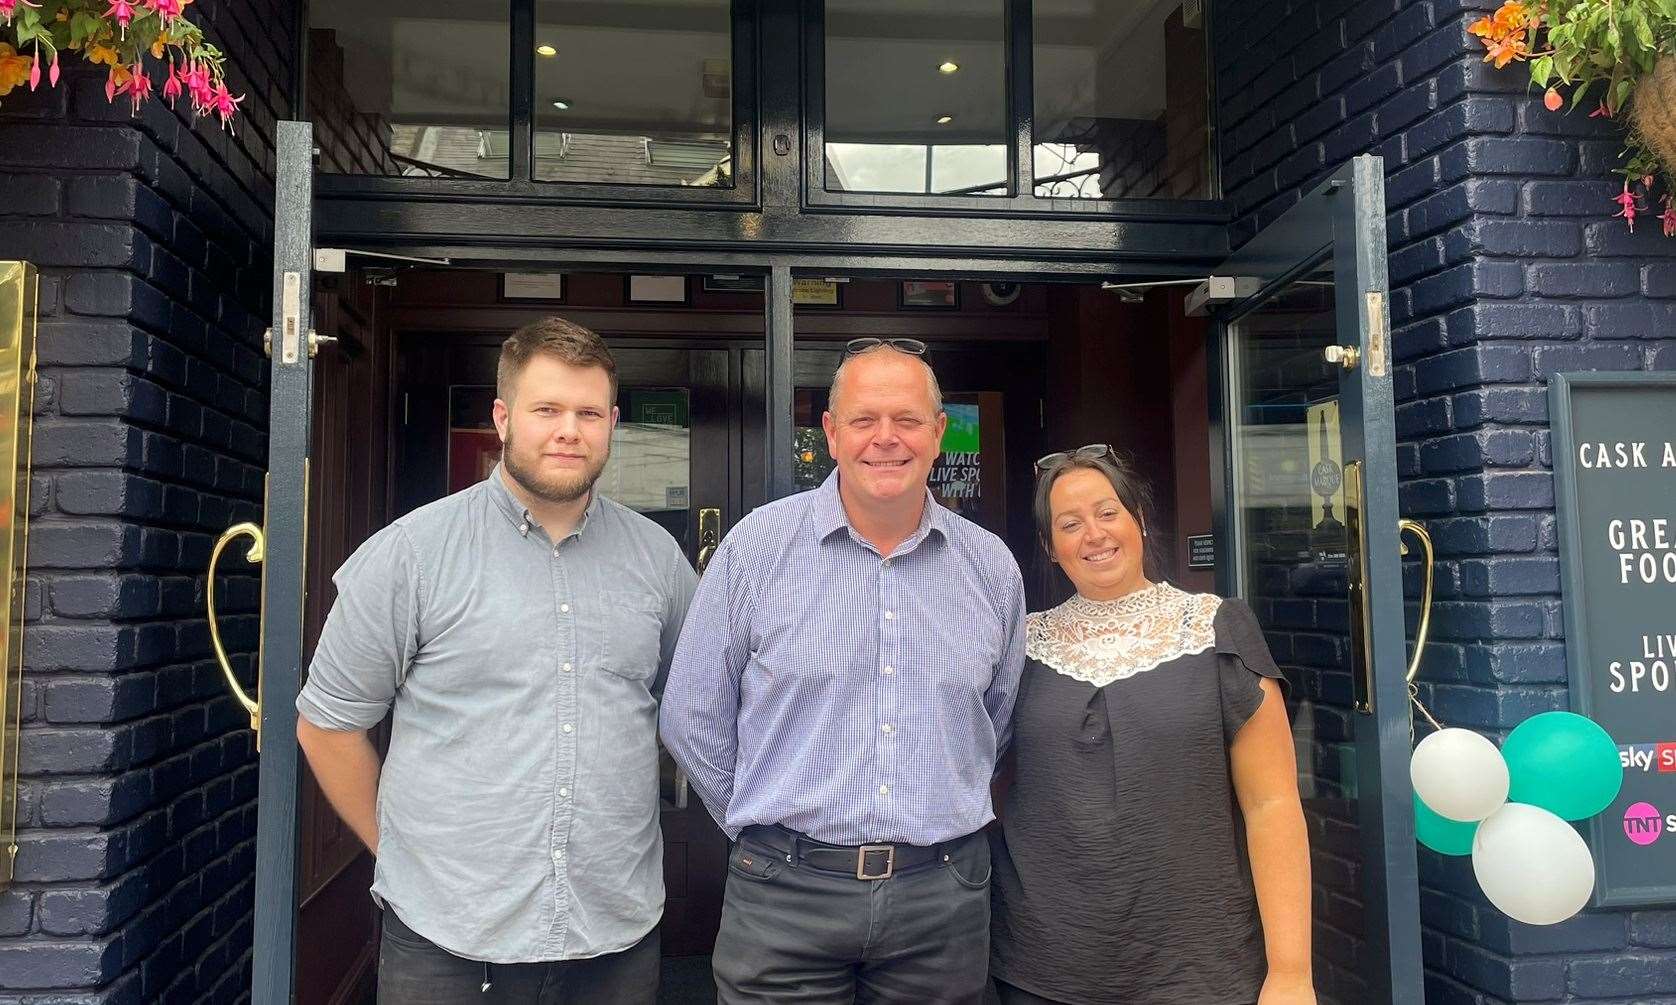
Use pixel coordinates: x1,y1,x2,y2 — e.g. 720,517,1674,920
1213,0,1676,1005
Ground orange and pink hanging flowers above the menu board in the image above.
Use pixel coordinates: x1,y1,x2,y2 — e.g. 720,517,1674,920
1468,0,1676,236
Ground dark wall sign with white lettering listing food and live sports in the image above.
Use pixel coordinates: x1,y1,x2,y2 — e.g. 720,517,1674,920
1549,374,1676,908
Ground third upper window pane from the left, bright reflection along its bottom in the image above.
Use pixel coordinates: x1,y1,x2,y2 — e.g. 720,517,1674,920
825,0,1007,196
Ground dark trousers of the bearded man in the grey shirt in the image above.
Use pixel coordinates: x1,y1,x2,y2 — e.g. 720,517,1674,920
379,911,662,1005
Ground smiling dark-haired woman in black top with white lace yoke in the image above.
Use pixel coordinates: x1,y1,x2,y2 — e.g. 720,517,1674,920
991,444,1316,1005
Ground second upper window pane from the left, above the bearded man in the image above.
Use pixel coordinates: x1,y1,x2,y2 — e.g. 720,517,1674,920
535,0,732,188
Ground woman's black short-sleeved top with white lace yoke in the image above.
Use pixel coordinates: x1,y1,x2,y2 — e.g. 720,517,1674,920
991,583,1280,1005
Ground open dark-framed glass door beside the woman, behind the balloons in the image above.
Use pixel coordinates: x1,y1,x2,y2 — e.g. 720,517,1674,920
1215,156,1423,1005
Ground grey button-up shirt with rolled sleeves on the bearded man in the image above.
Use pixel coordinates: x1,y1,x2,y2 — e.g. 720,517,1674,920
297,467,697,963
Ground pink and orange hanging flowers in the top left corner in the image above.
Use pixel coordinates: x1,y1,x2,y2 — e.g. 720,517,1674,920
0,0,245,129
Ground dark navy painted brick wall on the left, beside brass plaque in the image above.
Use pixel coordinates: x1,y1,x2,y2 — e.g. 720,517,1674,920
0,0,295,1003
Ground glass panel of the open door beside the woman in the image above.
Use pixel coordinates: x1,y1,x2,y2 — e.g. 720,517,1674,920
1229,260,1373,1002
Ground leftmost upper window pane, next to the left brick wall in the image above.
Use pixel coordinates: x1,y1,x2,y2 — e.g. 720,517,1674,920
308,0,511,178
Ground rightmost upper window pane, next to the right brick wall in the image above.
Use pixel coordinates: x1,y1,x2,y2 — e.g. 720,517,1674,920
1034,0,1210,199
